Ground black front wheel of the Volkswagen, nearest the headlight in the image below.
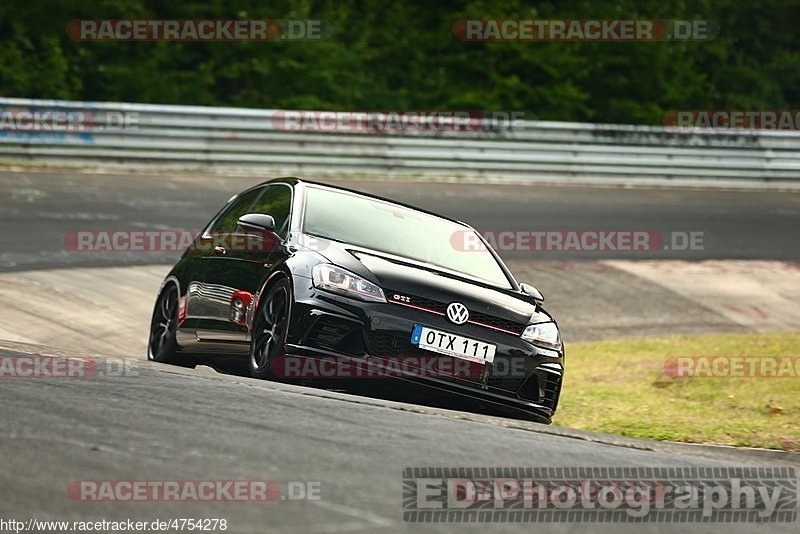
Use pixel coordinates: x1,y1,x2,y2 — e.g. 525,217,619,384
249,278,291,378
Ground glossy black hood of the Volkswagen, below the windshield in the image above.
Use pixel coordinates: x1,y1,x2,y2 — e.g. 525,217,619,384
306,238,543,324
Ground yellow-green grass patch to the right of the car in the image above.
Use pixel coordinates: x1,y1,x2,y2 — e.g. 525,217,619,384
553,332,800,451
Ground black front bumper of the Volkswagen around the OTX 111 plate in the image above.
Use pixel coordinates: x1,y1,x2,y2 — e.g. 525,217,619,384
285,278,564,422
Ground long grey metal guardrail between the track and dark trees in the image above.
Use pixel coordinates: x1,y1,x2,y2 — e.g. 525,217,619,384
0,98,800,186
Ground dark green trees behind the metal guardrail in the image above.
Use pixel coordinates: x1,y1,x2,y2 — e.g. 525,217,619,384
0,0,800,124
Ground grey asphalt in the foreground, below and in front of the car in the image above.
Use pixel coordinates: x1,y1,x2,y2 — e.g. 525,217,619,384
0,348,797,534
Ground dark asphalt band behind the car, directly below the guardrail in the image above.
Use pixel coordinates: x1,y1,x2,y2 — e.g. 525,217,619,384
0,172,800,270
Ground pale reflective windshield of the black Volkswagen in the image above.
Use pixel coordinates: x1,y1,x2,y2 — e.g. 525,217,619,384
303,187,510,287
